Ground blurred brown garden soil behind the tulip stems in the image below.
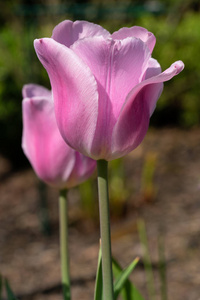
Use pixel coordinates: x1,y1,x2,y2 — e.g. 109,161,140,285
0,129,200,300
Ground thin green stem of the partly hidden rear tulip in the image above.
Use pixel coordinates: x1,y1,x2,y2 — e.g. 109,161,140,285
59,190,71,300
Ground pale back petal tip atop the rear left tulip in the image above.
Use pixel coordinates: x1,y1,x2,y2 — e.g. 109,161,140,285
22,83,52,99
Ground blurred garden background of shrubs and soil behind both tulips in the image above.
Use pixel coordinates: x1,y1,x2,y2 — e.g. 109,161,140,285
0,0,200,300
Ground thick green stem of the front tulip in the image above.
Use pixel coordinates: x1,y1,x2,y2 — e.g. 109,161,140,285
97,160,114,300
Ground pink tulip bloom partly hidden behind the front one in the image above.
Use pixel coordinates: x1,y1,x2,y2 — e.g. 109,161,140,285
22,84,96,189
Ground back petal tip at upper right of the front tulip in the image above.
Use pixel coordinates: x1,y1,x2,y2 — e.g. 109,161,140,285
111,26,156,53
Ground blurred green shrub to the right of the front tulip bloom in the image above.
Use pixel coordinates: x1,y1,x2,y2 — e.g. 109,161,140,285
138,13,200,127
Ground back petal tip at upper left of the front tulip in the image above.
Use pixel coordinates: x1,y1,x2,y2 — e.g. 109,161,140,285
52,20,110,47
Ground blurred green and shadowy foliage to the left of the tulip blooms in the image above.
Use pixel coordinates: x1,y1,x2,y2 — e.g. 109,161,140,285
0,24,49,166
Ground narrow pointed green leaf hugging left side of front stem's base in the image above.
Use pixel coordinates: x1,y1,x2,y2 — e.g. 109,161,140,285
94,246,103,300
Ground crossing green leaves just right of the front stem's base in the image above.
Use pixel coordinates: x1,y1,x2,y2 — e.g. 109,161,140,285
112,258,144,300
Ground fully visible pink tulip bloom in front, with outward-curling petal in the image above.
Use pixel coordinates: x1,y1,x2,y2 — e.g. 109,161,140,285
34,21,184,161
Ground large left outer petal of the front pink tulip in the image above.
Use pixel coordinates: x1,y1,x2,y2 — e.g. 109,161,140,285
35,38,98,156
